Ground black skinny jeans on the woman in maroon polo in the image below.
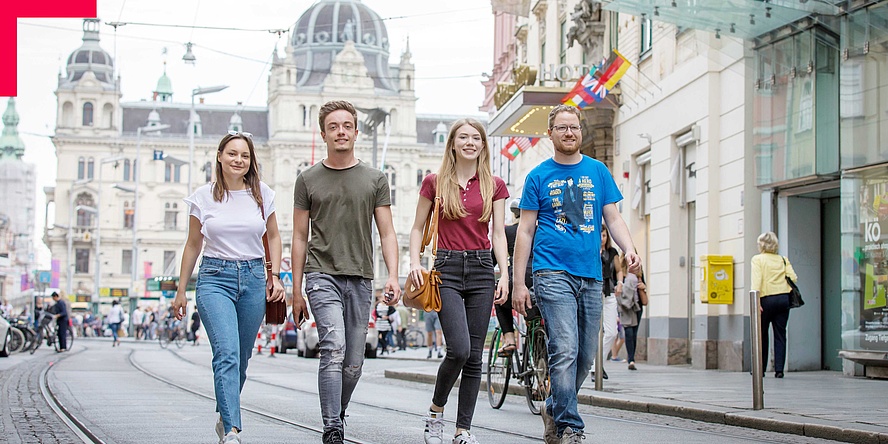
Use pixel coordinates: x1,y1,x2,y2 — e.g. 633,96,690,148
432,249,496,430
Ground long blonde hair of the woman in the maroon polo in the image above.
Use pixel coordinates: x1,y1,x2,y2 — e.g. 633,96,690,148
435,119,494,223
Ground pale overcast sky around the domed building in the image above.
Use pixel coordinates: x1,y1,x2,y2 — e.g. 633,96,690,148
13,0,493,268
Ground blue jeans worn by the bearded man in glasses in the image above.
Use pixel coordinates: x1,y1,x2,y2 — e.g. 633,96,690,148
533,270,602,436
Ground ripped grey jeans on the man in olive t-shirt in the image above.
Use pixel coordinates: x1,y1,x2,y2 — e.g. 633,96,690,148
305,272,373,431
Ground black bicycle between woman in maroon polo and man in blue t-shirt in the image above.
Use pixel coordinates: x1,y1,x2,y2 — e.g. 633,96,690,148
487,306,550,415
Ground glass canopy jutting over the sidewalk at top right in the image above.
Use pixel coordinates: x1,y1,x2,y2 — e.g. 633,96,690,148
601,0,845,39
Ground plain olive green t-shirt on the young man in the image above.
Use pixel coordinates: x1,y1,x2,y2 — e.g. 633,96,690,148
293,161,392,279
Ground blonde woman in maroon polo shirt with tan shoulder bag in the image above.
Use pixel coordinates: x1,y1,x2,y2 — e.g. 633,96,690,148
409,119,509,444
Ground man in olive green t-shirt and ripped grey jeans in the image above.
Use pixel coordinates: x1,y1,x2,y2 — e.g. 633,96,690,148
291,101,401,444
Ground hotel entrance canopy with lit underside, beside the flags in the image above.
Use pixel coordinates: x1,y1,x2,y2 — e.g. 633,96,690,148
487,85,614,137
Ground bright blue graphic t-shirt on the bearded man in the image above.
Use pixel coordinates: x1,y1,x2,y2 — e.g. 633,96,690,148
519,156,623,280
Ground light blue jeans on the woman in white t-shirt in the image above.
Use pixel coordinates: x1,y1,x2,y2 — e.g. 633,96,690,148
196,256,265,432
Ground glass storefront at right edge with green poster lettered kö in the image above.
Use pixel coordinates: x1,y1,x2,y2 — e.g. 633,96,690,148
838,2,888,351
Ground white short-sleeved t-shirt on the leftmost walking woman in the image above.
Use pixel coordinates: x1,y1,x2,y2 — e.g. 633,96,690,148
185,182,274,260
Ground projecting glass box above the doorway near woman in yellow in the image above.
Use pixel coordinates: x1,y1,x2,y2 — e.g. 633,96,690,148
753,25,839,185
